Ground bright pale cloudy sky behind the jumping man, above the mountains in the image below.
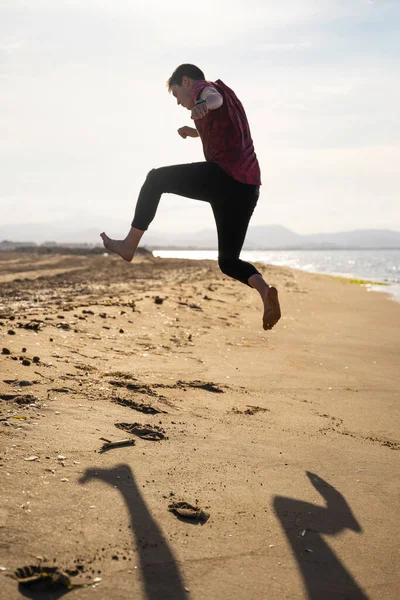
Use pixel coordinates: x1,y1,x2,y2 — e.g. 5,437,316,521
0,0,400,237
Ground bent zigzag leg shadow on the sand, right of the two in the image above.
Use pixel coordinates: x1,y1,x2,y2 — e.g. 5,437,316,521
273,471,368,600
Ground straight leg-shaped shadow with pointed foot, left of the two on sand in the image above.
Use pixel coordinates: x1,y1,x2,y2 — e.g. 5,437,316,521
79,465,188,600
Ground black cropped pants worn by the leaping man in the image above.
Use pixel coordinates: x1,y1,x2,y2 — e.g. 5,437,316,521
132,162,259,284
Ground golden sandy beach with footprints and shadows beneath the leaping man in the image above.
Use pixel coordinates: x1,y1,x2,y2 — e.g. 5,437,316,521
0,252,400,600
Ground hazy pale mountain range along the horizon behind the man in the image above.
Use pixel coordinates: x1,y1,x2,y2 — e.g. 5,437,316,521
0,219,400,250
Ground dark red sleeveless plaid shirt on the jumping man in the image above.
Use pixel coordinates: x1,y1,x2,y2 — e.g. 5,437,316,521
192,79,261,185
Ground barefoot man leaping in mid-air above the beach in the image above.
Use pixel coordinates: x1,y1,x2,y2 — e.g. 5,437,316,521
101,64,281,329
